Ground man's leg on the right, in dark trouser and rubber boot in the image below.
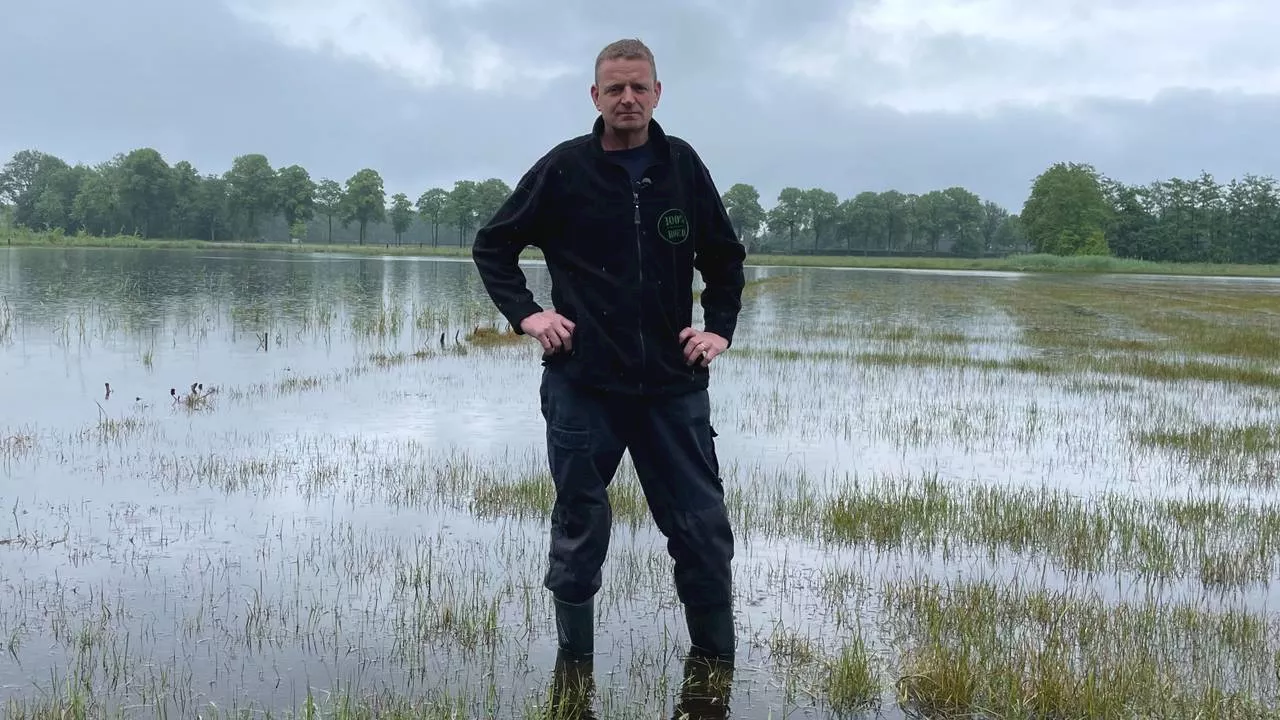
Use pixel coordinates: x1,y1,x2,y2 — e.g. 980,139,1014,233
627,391,733,657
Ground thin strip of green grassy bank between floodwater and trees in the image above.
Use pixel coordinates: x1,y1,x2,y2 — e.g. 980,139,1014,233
0,228,1280,278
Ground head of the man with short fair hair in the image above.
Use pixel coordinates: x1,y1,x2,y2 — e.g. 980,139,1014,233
591,40,662,135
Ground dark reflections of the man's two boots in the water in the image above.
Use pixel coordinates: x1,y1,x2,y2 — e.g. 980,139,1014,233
545,653,733,720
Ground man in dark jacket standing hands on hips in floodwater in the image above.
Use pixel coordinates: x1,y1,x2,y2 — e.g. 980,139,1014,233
472,40,745,661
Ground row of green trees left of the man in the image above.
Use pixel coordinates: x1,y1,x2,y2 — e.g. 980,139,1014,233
0,147,511,245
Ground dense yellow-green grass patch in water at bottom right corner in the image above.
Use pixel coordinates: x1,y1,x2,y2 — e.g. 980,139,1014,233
884,571,1280,717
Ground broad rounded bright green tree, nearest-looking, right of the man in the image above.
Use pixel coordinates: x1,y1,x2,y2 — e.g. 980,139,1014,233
1021,163,1111,255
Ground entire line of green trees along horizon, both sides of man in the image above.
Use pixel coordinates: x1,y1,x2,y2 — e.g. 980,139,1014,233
0,147,1280,263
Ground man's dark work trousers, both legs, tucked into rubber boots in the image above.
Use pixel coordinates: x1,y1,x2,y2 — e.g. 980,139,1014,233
540,369,733,609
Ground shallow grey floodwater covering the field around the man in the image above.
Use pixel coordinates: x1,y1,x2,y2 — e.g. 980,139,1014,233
0,243,1280,717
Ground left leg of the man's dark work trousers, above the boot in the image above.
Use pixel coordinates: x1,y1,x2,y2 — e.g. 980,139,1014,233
540,370,625,605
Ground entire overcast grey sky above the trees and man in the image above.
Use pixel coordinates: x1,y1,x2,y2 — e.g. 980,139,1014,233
0,0,1280,211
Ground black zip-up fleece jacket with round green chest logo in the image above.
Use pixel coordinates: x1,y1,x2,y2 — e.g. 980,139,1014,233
472,118,746,393
